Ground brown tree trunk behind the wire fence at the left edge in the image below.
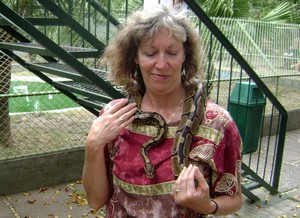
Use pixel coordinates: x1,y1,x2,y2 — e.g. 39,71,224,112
0,30,12,147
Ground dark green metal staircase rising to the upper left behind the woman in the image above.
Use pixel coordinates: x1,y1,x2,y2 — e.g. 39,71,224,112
0,0,123,115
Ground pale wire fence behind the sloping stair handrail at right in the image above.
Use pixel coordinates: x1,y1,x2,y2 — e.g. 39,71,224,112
199,18,300,113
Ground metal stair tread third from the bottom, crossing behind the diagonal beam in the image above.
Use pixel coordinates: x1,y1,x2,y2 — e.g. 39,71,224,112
0,42,100,58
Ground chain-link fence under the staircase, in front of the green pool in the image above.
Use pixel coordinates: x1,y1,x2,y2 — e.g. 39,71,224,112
0,28,95,160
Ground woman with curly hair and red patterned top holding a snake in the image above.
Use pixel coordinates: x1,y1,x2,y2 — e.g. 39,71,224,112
83,6,242,217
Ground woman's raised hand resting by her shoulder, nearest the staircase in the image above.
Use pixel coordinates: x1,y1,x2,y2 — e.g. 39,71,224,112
86,99,137,149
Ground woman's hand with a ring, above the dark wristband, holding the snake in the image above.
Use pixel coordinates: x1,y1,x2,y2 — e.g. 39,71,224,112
174,165,214,214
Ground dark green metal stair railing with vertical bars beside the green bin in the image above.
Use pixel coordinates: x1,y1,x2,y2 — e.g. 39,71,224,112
186,1,287,201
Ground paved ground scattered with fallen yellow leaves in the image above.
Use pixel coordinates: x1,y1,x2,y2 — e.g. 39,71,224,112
0,130,300,218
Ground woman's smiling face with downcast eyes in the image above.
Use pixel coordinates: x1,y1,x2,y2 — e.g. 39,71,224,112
135,29,185,94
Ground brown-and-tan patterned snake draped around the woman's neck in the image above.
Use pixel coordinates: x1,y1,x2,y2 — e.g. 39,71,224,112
129,82,206,178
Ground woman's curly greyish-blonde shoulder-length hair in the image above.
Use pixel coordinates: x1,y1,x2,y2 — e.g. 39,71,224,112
103,5,202,94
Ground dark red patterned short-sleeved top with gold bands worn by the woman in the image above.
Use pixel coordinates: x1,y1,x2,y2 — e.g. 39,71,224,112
102,101,242,218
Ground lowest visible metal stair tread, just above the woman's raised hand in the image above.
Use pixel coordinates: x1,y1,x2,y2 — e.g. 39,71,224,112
53,81,112,103
